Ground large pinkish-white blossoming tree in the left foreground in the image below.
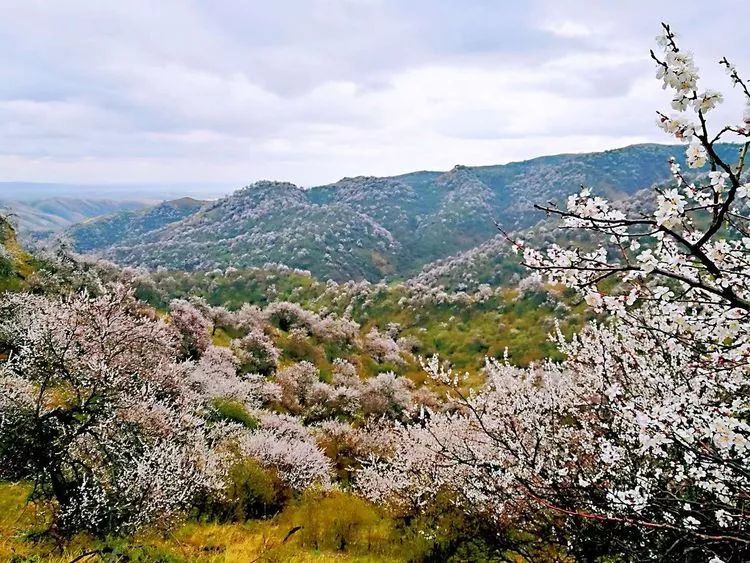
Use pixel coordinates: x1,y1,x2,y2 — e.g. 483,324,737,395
0,286,221,535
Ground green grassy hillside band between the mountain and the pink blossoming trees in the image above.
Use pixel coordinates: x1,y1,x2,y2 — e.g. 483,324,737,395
139,269,588,383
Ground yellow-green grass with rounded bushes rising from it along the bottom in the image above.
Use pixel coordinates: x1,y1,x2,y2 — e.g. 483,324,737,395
0,482,565,563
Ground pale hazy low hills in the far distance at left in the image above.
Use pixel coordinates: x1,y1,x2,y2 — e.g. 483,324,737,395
0,197,145,234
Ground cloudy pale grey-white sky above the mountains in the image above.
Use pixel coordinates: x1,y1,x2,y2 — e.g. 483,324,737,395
0,0,750,193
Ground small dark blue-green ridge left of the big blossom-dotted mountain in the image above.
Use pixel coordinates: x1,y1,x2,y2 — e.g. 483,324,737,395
66,197,207,252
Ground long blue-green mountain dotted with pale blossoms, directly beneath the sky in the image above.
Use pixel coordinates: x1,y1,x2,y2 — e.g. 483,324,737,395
63,144,737,281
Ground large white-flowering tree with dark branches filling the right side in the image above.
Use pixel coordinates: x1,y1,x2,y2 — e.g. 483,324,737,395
360,25,750,561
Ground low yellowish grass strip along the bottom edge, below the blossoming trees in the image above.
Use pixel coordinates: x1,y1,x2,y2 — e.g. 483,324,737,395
0,483,429,563
